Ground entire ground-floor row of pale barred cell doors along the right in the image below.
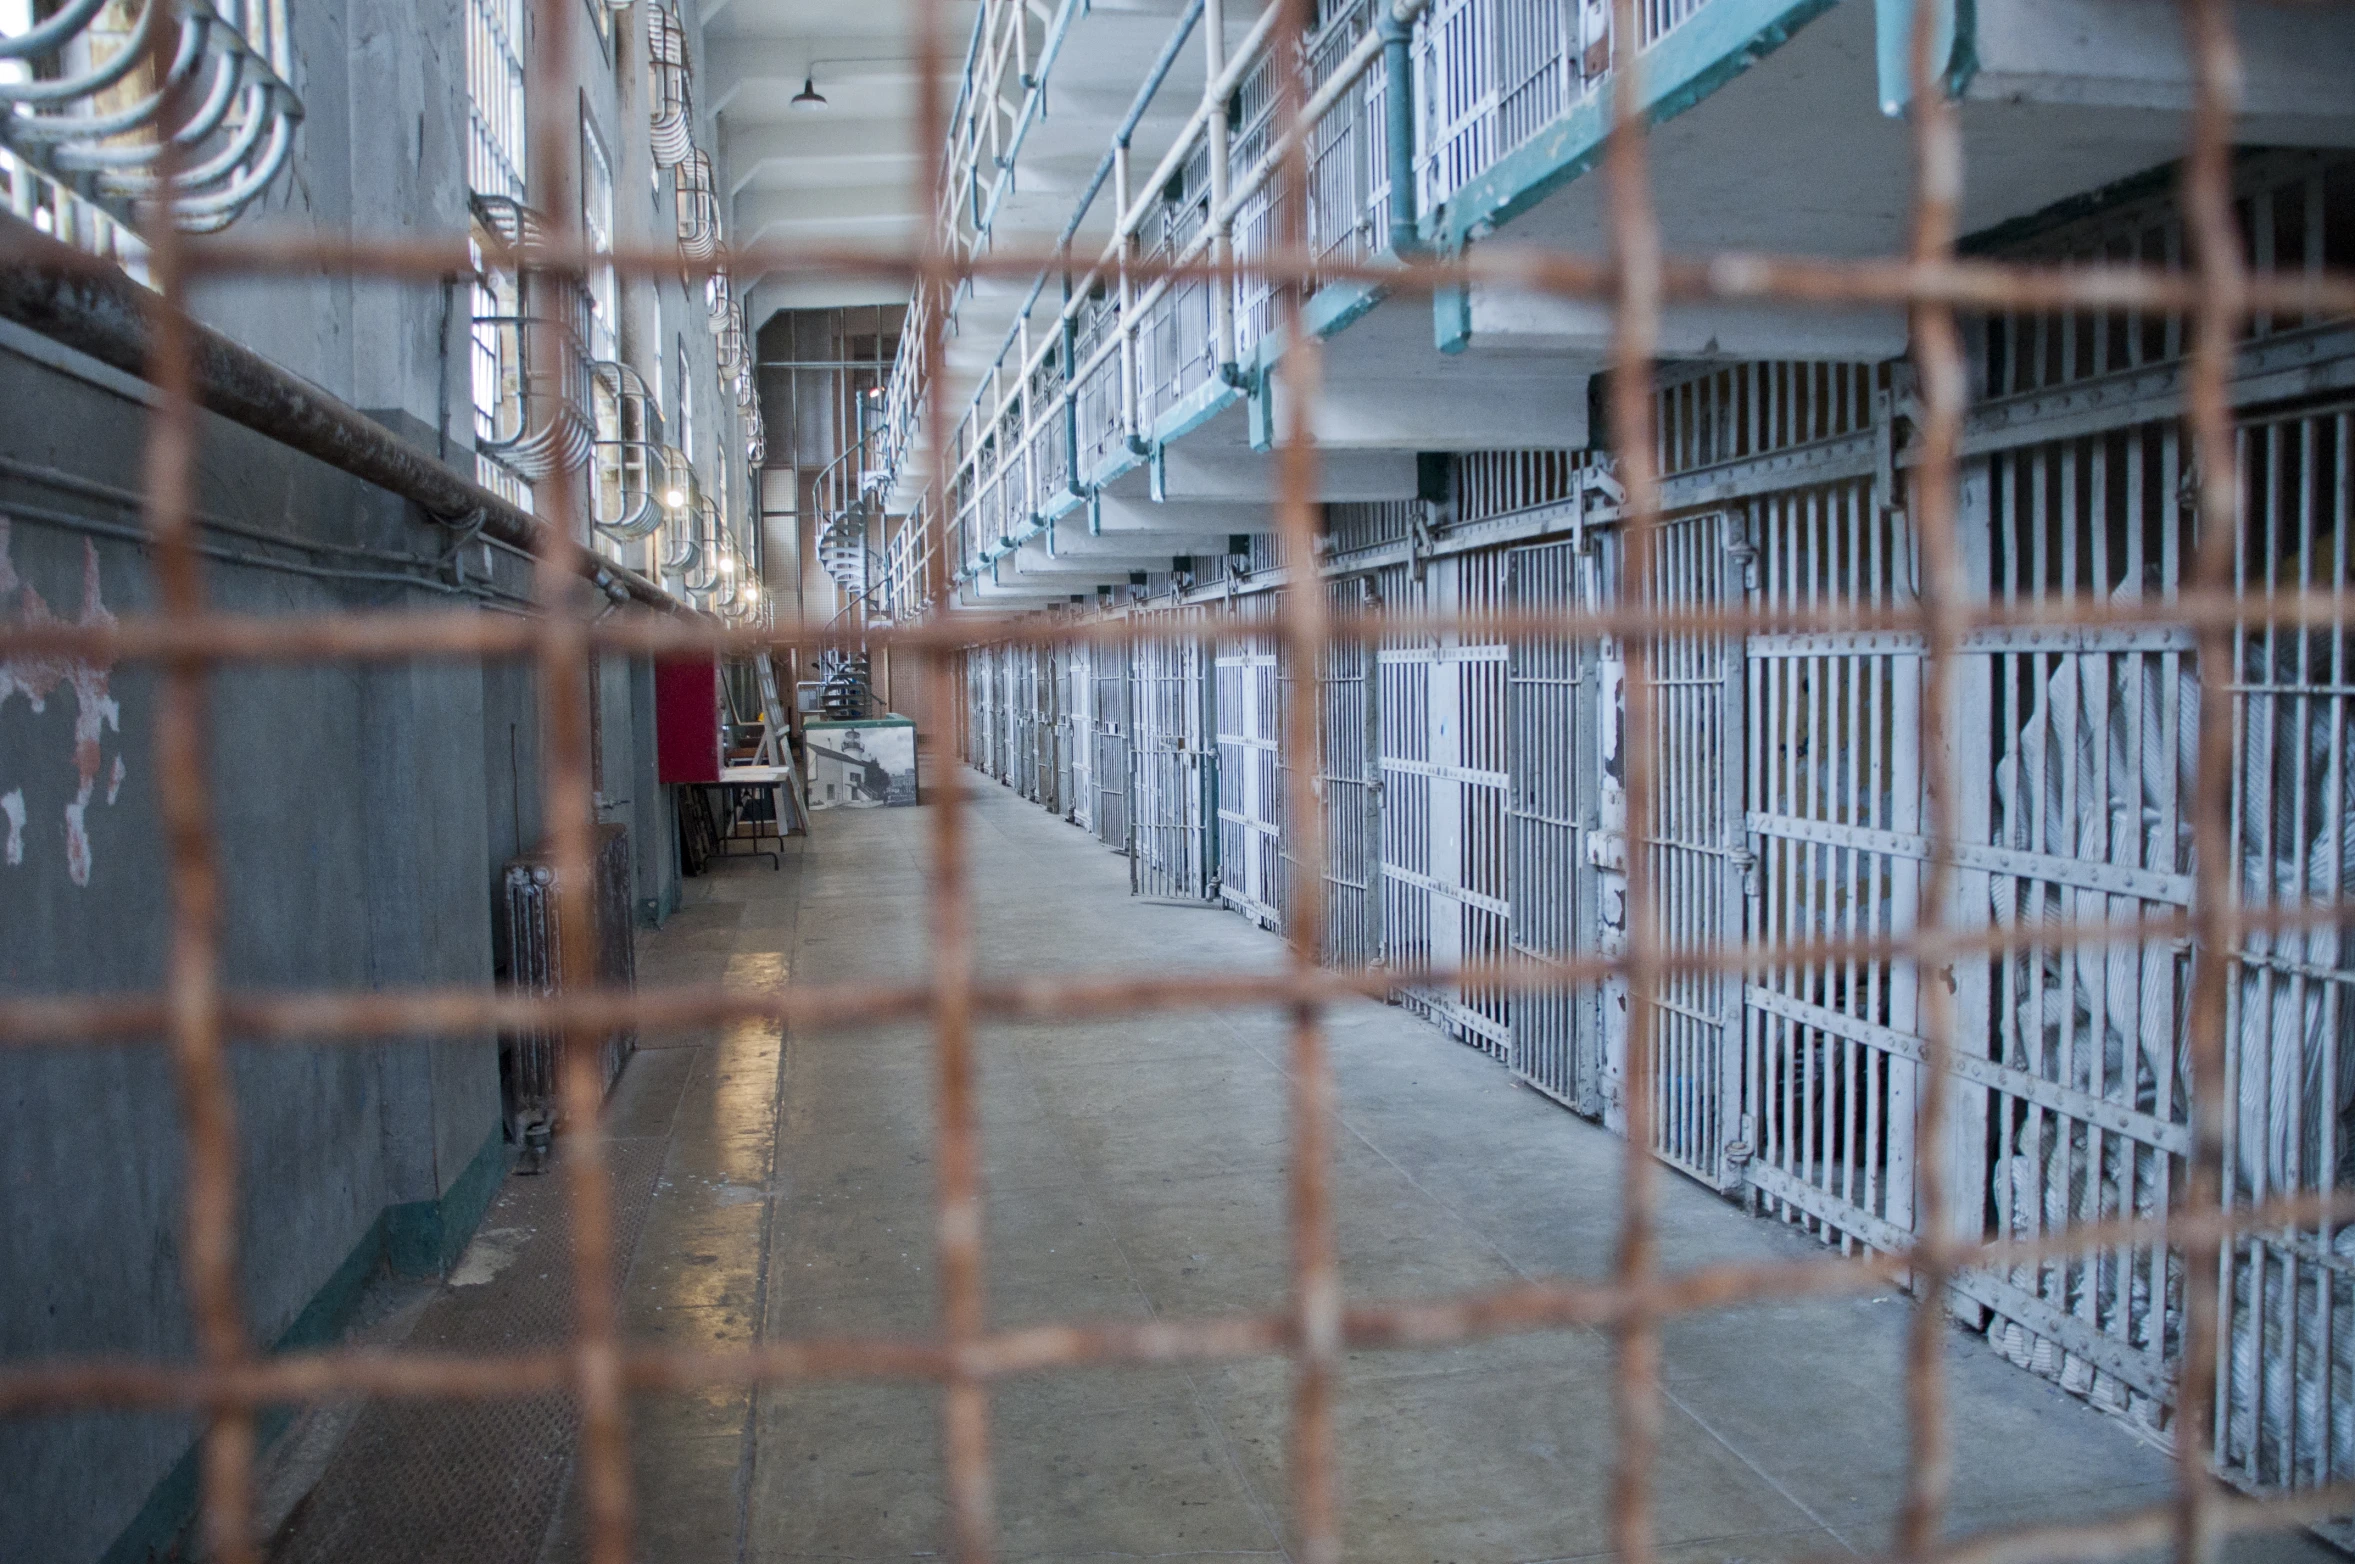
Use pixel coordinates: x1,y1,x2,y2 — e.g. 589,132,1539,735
977,405,2355,1489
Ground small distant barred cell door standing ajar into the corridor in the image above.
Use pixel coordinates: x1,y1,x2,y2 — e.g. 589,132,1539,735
1128,641,1218,902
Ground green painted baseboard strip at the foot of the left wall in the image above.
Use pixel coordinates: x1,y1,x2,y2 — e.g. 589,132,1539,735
99,1124,509,1564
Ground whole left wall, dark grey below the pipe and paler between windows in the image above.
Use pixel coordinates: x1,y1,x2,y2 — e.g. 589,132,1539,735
0,0,697,1564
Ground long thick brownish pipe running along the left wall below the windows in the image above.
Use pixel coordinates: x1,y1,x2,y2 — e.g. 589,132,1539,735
0,214,685,612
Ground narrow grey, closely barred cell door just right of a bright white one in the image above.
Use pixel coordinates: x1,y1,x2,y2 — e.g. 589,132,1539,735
1505,542,1604,1119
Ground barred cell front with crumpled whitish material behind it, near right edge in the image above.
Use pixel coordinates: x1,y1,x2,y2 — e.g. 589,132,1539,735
1957,424,2185,1425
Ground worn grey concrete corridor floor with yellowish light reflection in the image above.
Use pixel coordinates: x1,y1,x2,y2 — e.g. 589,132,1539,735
270,780,2336,1564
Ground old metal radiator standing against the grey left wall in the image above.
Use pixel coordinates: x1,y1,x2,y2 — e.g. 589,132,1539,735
499,824,638,1142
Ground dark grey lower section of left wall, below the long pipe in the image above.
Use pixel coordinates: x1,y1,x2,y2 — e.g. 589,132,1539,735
0,317,676,1564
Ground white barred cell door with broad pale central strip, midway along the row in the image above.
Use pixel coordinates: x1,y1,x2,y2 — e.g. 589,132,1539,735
1375,554,1512,1058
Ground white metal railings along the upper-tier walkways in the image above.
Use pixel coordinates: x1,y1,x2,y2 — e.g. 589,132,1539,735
876,0,1707,602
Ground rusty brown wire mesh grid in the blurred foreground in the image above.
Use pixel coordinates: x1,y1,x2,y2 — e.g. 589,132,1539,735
13,0,2355,1564
